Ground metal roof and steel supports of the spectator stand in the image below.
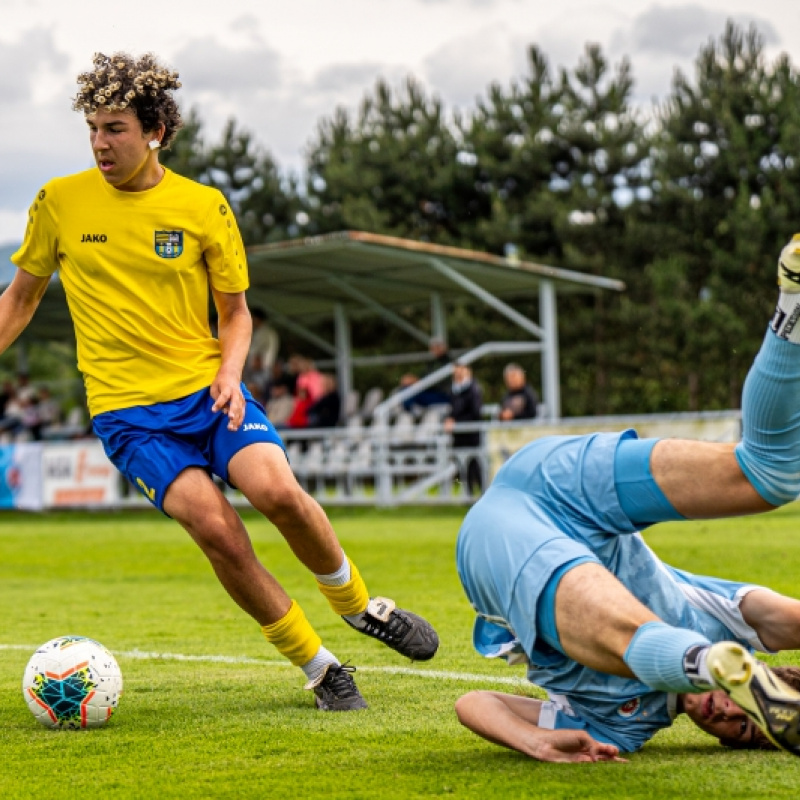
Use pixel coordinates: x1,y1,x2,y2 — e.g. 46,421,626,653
0,231,625,419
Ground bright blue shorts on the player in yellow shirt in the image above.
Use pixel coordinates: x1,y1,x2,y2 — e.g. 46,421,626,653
92,384,285,512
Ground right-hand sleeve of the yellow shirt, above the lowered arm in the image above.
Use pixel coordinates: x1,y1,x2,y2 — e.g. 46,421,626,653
203,192,250,294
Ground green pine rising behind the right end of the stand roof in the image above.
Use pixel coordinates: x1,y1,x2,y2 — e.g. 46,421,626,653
454,45,647,414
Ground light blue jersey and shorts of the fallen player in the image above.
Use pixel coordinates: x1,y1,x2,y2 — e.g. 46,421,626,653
457,431,765,752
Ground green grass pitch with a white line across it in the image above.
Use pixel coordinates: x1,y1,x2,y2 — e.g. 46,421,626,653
0,505,800,800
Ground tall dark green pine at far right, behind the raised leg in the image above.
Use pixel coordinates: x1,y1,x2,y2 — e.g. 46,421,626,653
640,23,800,410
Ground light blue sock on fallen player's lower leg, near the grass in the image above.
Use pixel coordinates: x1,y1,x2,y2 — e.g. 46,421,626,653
622,621,711,692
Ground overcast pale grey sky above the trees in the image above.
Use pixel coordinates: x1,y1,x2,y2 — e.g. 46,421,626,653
0,0,800,244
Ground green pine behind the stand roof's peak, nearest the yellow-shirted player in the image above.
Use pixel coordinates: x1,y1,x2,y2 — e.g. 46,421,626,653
306,78,484,244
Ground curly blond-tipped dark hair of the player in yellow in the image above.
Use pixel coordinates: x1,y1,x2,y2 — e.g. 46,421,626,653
72,53,183,149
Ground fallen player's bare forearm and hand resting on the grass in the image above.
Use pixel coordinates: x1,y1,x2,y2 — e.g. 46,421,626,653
456,691,625,762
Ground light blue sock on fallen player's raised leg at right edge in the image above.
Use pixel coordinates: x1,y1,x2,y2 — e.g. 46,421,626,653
736,329,800,506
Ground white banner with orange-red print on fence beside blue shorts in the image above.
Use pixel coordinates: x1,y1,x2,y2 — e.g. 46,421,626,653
42,441,120,508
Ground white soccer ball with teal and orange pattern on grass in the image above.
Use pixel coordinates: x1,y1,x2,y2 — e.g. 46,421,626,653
22,636,122,730
